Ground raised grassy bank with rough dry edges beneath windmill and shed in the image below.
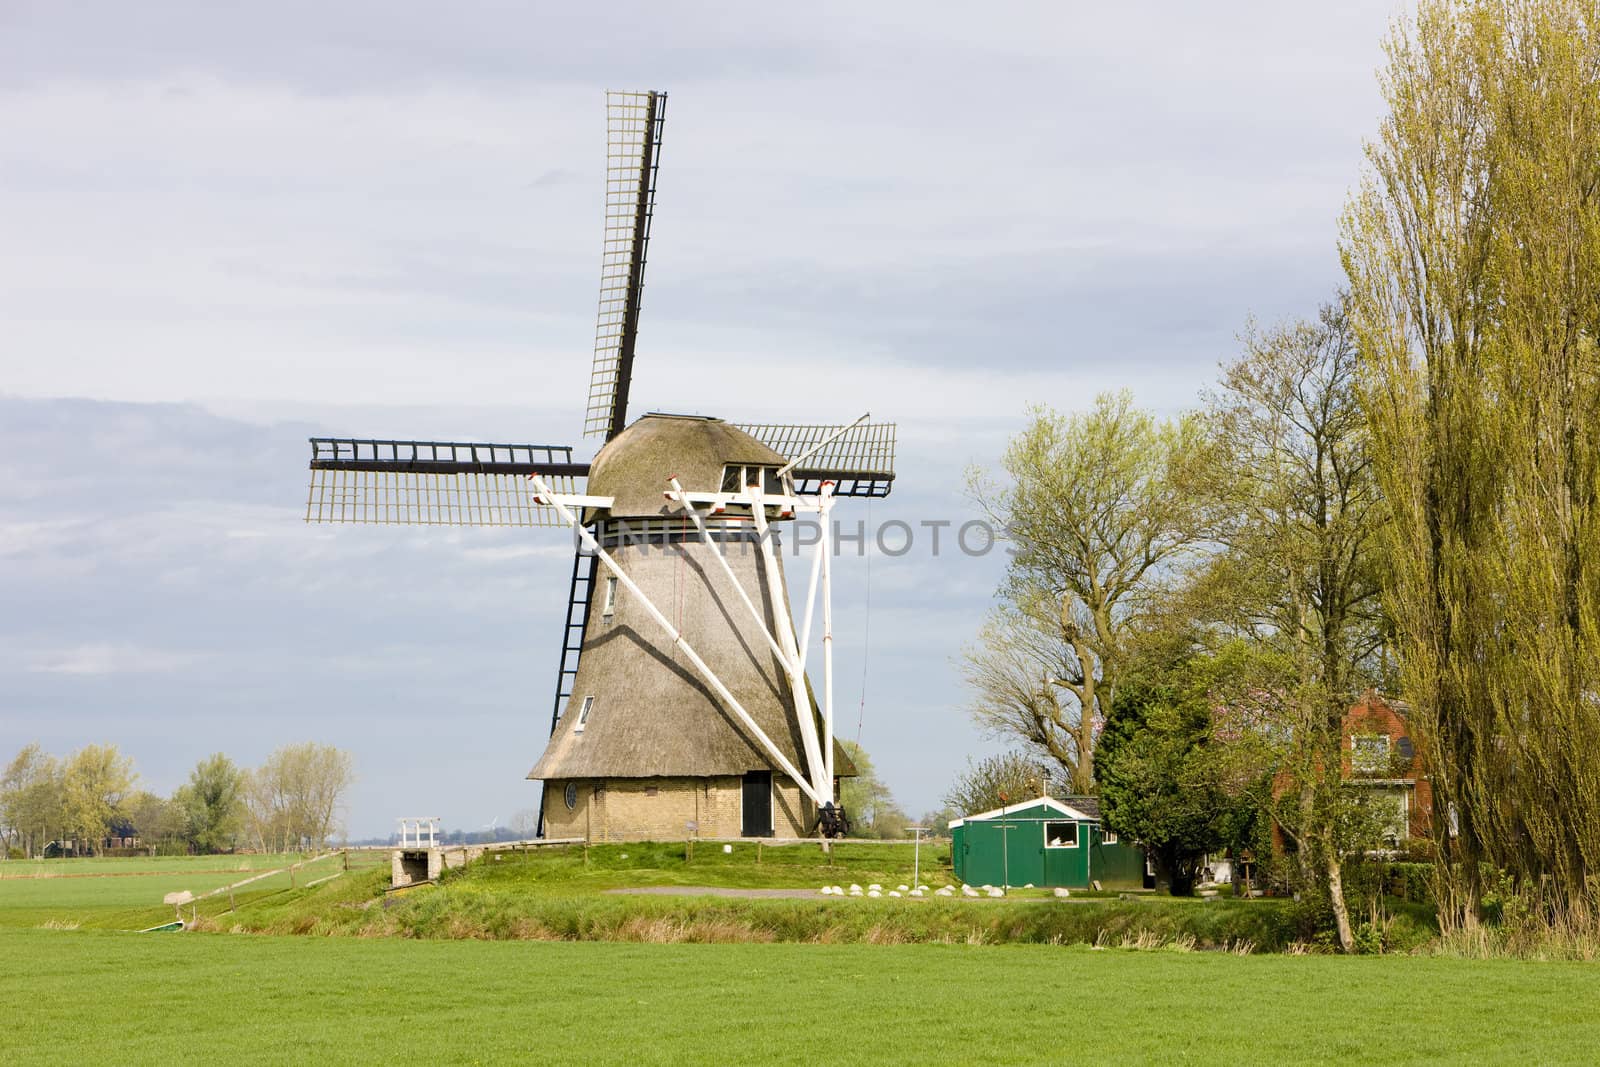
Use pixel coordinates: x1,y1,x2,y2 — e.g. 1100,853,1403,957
205,845,1296,950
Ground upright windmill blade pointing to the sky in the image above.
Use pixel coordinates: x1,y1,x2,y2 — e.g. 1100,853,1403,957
584,93,667,440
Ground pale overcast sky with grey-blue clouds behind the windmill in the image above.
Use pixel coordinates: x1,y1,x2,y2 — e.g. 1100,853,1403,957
0,0,1400,837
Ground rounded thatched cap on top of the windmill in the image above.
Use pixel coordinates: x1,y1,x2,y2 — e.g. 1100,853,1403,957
589,413,786,518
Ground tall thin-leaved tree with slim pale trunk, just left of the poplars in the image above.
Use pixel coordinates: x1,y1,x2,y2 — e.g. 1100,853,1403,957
1189,306,1386,952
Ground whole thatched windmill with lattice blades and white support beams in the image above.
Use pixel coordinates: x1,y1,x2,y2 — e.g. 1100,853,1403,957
306,93,894,840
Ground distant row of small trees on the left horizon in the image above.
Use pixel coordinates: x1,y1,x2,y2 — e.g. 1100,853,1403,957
0,742,355,857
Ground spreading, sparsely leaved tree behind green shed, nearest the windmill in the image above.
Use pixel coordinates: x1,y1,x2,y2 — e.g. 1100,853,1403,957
965,392,1200,793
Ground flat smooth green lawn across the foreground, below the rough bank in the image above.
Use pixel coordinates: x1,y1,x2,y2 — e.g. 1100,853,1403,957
0,929,1600,1064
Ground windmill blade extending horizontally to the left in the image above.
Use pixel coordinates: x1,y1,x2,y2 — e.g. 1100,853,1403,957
306,437,589,526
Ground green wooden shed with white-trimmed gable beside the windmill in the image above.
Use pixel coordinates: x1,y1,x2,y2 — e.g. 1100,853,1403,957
950,797,1144,889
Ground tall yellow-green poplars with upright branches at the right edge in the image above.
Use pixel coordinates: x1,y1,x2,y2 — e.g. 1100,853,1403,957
1342,0,1600,928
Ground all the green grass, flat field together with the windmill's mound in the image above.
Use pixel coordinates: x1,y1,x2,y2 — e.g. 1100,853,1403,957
0,845,1600,1064
